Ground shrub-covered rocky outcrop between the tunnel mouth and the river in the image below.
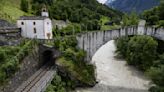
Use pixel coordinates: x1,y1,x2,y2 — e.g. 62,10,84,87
48,37,96,89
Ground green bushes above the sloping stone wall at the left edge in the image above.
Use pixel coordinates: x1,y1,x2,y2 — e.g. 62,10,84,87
0,41,34,85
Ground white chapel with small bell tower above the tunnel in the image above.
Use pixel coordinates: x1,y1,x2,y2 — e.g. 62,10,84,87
17,8,53,39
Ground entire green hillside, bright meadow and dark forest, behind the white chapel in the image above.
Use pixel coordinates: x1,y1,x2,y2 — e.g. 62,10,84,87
0,0,122,30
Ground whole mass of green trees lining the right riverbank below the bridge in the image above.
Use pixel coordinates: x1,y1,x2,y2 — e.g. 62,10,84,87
116,36,164,92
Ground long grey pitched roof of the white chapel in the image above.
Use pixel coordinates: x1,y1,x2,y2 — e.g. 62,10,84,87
18,16,48,20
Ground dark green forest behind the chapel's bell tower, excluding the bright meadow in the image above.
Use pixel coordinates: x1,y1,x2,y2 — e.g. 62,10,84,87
32,0,121,30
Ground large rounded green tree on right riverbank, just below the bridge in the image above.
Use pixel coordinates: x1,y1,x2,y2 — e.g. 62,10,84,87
126,36,158,70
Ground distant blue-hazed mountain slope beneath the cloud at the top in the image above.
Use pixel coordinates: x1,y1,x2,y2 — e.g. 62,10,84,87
106,0,159,13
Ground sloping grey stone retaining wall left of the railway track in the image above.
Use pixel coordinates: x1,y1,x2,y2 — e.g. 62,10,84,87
0,47,41,92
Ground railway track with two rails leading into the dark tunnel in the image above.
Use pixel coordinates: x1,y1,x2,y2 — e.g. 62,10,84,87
15,64,54,92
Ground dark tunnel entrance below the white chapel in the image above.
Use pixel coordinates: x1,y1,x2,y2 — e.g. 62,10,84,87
41,50,54,65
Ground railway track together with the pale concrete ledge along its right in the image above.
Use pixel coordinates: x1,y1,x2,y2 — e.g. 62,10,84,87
15,64,55,92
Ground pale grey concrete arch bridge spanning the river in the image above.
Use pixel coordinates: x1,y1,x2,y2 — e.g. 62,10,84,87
76,26,164,62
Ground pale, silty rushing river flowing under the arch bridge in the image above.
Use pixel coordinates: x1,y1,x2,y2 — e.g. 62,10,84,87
77,40,150,92
